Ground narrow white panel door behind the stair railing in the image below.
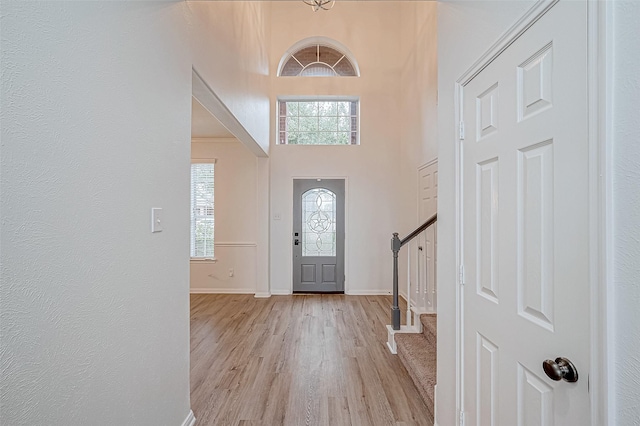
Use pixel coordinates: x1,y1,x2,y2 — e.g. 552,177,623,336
414,162,438,312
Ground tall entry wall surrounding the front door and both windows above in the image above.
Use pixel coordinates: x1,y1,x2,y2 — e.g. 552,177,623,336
270,2,403,294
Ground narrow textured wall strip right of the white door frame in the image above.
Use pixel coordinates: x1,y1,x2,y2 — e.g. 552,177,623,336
612,1,640,425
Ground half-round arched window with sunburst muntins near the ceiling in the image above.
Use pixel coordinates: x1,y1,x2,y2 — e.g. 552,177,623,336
278,37,360,77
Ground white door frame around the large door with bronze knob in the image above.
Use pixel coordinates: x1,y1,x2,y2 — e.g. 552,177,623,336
450,0,615,426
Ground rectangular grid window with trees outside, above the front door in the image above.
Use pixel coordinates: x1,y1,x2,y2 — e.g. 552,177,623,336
278,99,358,145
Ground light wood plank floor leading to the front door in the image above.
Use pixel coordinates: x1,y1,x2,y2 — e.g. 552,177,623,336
191,295,431,426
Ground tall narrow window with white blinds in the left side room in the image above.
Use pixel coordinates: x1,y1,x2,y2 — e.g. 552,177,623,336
191,163,215,259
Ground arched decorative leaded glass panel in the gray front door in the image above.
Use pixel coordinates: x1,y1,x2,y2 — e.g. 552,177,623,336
302,188,336,256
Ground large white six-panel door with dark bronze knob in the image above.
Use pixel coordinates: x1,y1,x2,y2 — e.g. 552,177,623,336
461,1,590,426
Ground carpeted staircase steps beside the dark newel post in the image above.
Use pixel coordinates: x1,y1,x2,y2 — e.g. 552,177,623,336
395,314,438,421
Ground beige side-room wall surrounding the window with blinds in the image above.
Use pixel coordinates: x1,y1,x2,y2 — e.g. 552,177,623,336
191,139,258,293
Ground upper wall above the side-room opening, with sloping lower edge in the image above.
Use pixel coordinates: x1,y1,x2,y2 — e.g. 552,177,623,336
185,1,271,153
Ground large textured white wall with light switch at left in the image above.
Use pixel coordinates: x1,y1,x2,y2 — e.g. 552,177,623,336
0,1,191,426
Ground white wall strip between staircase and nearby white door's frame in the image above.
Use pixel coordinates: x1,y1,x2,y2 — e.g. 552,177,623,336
436,1,533,426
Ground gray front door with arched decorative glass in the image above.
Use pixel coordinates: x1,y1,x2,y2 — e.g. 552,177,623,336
292,179,344,293
